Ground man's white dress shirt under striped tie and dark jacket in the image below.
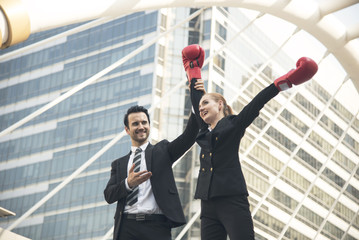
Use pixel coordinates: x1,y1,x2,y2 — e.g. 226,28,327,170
124,142,162,214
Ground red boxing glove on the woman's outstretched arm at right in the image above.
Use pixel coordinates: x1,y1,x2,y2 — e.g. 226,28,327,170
274,57,318,91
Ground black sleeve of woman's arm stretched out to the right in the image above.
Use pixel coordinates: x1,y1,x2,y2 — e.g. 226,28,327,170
235,83,279,129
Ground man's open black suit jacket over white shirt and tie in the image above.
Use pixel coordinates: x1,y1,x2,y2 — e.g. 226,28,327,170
104,114,199,239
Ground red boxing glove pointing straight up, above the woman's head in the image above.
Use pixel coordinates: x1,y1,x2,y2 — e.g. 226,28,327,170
182,44,205,81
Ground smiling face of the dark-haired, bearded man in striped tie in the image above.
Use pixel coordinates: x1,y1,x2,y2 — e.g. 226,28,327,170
125,112,150,147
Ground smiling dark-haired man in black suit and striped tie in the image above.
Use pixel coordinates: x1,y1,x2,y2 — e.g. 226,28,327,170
104,100,201,240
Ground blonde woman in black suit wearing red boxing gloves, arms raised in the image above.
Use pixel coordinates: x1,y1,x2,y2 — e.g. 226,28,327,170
182,45,317,240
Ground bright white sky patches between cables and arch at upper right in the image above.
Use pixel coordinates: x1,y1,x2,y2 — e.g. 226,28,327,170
248,2,359,114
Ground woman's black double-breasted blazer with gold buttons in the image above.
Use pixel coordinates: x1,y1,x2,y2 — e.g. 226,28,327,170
191,84,279,200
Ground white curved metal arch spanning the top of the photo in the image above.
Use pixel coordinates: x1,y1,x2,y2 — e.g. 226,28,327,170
0,0,359,91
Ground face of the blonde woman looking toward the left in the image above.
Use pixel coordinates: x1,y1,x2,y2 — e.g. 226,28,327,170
199,94,223,124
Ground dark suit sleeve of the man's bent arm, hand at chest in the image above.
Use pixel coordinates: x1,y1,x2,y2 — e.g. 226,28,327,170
104,161,128,204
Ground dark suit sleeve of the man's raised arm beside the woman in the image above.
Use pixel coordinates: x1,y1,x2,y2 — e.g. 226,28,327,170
168,113,199,162
